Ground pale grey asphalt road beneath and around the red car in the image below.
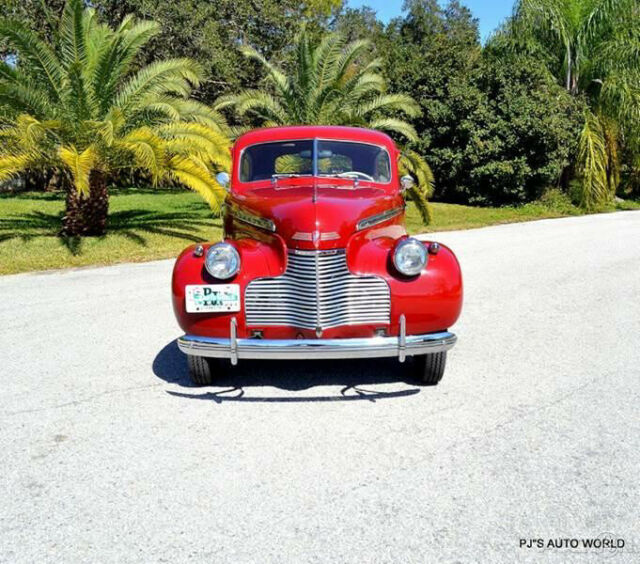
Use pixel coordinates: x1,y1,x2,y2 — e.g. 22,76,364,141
0,212,640,563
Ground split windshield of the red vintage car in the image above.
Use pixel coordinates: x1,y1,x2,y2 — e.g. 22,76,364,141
240,139,391,184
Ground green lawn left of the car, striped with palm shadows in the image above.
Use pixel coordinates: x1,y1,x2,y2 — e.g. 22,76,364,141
0,189,222,274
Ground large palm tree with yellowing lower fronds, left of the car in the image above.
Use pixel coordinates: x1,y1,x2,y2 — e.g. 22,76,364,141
0,0,229,235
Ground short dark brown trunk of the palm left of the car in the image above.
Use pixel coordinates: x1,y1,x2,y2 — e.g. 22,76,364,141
61,170,109,236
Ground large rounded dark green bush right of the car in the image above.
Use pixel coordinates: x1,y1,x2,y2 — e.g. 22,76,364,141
430,52,581,205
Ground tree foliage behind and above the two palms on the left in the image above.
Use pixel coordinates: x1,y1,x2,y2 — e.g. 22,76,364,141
0,0,341,102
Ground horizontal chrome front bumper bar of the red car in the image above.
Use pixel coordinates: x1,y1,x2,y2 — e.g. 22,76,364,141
178,331,457,359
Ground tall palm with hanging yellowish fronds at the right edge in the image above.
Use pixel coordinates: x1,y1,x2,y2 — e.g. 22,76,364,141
508,0,640,208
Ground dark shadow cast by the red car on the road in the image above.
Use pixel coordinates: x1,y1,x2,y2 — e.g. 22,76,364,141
153,341,420,403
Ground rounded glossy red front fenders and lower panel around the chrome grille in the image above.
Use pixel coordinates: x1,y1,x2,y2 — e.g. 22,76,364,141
172,232,463,338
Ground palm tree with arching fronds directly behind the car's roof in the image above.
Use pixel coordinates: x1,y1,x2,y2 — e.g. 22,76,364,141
214,30,433,223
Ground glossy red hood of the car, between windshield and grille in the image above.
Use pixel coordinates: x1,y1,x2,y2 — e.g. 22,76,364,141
231,185,403,249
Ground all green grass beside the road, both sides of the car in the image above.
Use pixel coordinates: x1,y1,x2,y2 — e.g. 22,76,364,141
0,189,640,274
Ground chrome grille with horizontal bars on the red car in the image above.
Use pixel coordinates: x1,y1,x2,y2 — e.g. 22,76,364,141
245,249,391,329
